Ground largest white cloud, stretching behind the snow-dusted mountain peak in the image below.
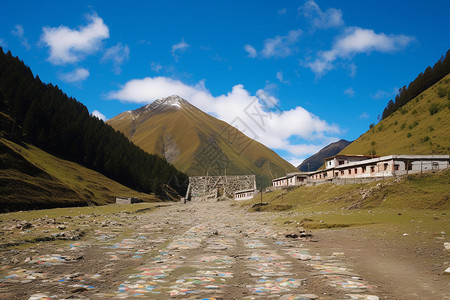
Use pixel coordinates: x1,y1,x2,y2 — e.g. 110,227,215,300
108,77,340,156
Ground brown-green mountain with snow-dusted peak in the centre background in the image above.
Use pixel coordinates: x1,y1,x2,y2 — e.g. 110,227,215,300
107,96,296,186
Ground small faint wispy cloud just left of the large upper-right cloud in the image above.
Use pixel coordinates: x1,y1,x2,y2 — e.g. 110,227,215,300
261,29,302,58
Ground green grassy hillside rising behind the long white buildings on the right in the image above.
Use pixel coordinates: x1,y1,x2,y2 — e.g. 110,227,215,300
340,74,450,156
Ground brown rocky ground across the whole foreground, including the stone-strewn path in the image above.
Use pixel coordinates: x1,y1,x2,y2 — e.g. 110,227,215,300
0,201,450,300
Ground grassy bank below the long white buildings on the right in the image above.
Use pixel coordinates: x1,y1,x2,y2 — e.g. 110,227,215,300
242,170,450,228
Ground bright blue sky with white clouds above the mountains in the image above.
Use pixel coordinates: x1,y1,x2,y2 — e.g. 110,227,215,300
0,0,450,165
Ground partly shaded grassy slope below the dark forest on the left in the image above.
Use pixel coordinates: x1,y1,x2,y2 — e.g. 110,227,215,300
0,139,157,211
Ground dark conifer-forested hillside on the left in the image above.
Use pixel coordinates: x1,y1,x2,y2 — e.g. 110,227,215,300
0,47,187,197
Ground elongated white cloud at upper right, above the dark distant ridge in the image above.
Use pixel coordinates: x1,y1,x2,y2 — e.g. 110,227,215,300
306,27,414,77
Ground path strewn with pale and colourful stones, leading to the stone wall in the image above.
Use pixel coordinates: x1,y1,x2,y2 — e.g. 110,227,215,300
0,202,380,299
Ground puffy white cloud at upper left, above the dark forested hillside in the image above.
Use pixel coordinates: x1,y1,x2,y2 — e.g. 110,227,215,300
41,14,109,65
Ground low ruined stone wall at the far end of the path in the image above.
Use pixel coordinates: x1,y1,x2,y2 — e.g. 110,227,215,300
186,175,256,201
